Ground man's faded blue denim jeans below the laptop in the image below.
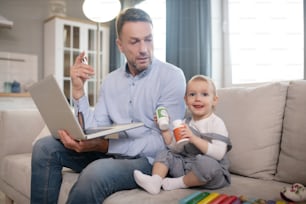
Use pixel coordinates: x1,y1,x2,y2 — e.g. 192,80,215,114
31,137,152,204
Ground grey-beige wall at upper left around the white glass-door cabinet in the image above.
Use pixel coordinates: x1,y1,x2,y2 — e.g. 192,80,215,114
0,0,86,79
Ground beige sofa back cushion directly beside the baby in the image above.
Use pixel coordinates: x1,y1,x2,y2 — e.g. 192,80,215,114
216,83,288,179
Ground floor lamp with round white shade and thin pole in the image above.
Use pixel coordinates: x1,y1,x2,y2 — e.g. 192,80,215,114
82,0,121,102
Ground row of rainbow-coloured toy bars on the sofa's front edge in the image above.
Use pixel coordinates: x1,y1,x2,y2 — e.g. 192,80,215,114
179,191,293,204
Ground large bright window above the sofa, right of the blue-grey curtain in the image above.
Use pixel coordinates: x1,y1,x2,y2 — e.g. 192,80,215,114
225,0,304,85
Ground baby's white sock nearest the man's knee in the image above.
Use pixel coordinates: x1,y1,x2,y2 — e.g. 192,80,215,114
134,170,163,194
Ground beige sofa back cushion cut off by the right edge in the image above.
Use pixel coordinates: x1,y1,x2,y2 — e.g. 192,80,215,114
276,80,306,185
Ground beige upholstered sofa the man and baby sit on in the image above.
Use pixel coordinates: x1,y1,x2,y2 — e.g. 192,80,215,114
0,80,306,204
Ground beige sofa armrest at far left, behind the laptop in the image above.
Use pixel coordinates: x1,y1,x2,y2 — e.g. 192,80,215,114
0,109,45,159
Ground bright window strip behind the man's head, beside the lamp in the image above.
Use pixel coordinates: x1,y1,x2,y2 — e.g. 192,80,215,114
135,0,166,61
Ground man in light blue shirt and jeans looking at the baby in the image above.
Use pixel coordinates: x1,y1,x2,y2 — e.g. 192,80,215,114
31,8,186,204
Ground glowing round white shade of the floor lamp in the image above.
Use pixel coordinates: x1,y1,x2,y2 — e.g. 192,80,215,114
82,0,121,23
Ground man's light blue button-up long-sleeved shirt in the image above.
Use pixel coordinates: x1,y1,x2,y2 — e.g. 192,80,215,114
74,59,186,162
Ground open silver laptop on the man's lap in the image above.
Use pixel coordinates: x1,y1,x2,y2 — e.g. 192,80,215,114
29,75,144,140
